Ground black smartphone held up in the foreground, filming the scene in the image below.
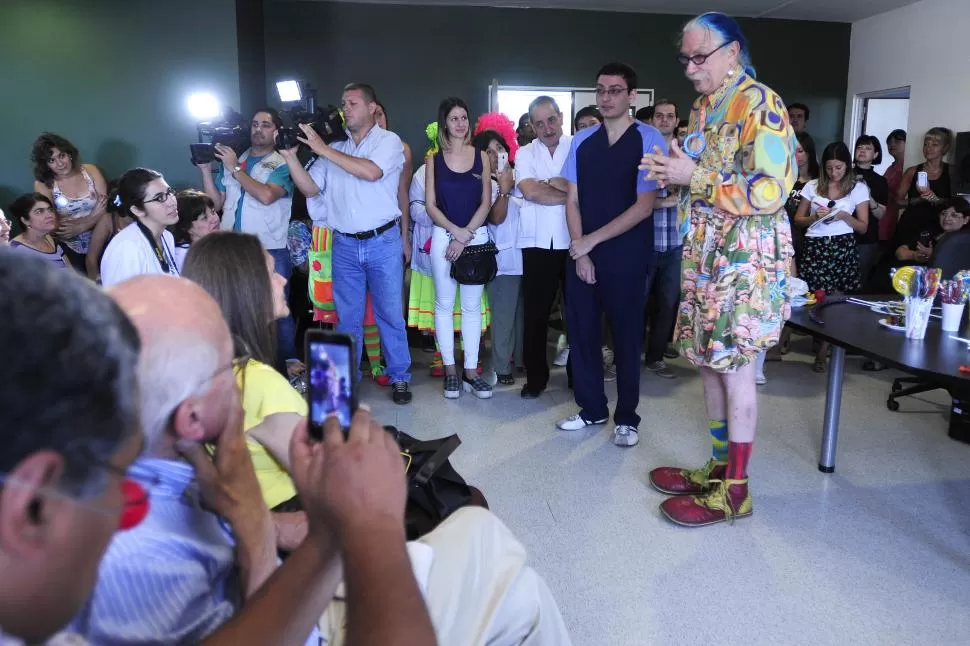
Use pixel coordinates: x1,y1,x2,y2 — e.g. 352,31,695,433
306,330,357,439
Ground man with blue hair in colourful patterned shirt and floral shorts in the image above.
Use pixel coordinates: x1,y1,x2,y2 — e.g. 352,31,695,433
643,13,797,527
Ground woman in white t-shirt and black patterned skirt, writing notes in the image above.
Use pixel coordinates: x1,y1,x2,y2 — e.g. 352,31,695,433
795,141,869,372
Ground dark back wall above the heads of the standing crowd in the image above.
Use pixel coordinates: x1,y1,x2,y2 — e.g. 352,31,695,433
266,0,850,159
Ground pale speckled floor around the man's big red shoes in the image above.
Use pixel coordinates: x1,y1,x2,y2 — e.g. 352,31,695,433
361,339,970,646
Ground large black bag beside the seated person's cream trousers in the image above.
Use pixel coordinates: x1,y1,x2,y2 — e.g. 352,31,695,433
385,427,488,541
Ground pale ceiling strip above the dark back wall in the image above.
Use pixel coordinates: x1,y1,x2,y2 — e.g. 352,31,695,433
294,0,918,22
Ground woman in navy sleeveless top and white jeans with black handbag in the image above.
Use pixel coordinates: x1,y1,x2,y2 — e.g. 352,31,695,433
425,97,492,399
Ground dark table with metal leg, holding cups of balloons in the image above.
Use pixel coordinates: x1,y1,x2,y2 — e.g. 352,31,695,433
788,296,970,473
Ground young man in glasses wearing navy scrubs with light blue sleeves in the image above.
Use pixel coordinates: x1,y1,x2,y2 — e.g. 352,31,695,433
557,63,667,446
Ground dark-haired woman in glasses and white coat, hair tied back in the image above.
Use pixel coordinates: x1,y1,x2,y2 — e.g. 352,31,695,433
101,168,179,287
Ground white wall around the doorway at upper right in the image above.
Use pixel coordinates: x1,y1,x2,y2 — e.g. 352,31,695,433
845,0,970,165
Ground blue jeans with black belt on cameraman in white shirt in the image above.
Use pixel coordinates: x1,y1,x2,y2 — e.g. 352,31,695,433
332,226,411,383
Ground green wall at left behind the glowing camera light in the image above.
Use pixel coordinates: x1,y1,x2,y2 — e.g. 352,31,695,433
0,0,239,208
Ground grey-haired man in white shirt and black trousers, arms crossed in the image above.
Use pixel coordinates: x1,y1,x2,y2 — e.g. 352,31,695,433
515,96,572,399
